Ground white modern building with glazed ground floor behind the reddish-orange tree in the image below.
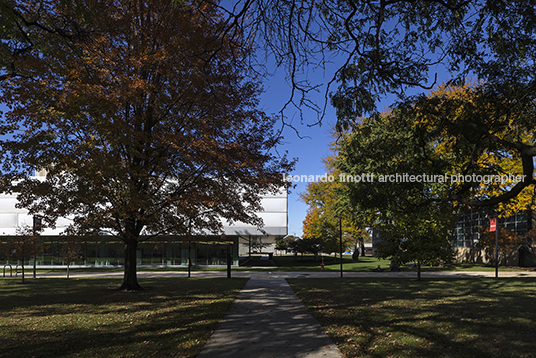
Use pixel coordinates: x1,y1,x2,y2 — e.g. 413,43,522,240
0,176,288,266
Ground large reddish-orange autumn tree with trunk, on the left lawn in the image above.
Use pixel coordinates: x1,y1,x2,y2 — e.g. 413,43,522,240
0,0,292,290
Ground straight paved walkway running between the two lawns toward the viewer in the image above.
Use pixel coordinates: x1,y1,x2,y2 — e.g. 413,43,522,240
197,275,342,358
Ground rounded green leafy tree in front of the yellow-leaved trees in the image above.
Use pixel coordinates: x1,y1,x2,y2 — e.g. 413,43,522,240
336,96,457,277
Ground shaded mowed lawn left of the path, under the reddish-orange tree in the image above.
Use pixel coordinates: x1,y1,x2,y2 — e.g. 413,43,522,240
0,278,247,358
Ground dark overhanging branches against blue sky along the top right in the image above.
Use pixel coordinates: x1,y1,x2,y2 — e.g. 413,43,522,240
187,0,536,124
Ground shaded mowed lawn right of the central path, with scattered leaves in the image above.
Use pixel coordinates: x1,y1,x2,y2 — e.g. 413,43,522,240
288,278,536,358
